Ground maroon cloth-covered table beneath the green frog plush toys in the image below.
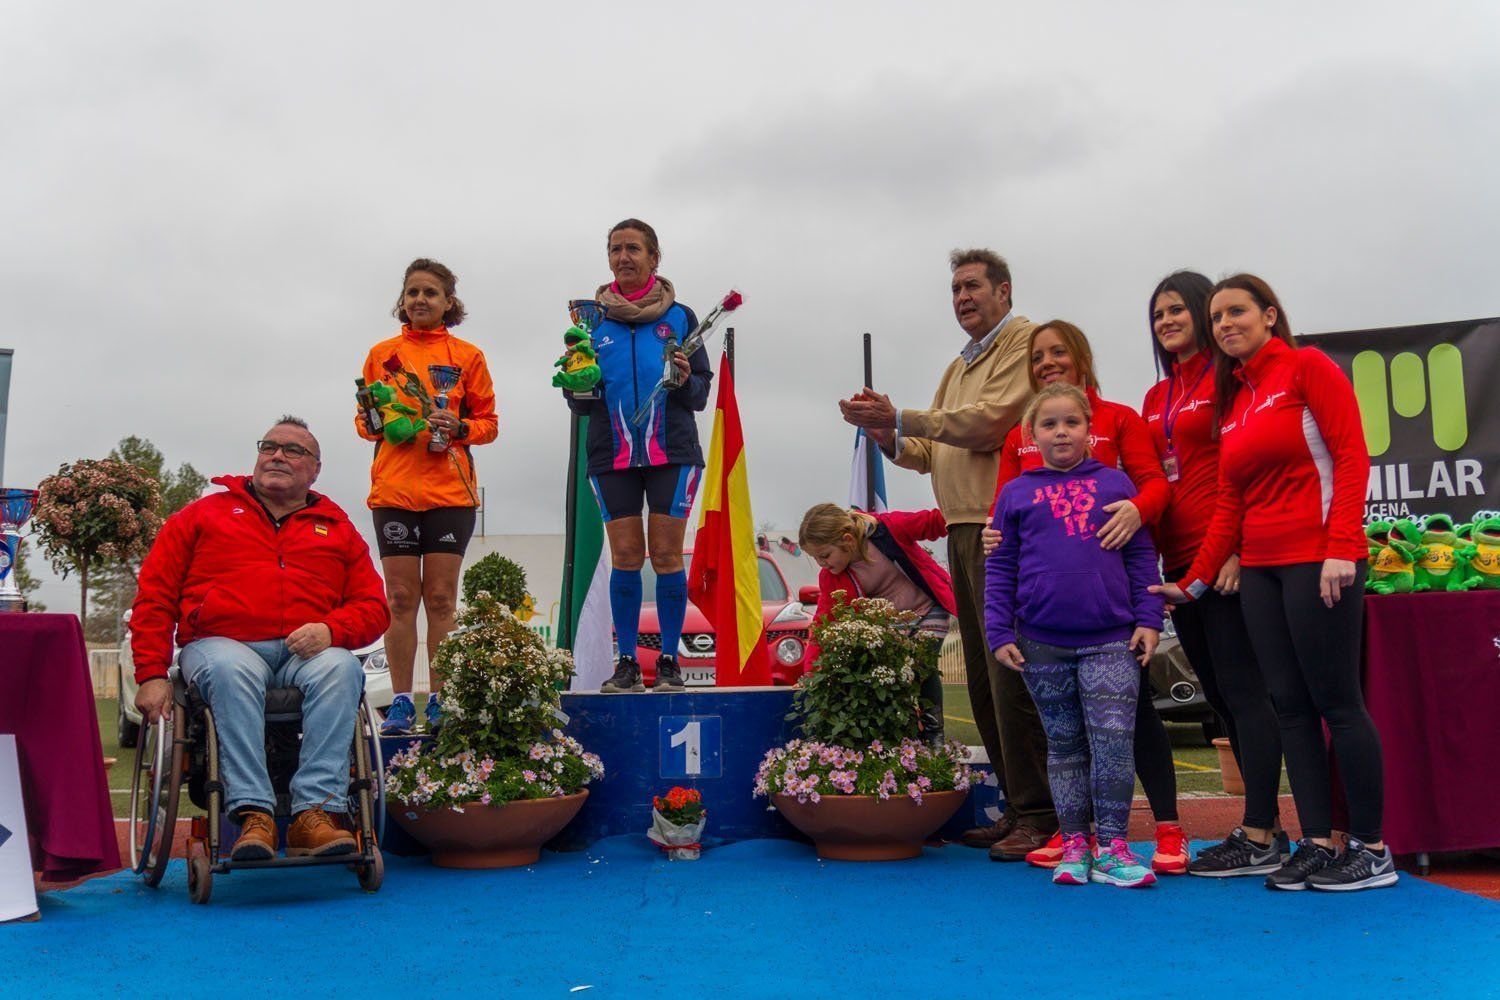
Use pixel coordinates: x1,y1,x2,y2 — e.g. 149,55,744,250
1362,591,1500,855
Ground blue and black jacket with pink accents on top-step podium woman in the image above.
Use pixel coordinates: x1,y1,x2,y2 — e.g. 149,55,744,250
569,303,714,475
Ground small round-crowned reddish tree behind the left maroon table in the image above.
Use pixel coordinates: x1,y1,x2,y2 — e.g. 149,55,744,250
32,459,162,622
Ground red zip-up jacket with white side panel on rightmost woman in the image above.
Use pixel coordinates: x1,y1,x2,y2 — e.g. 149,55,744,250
1179,340,1370,597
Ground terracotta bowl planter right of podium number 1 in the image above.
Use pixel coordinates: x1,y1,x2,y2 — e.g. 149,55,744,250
771,792,969,861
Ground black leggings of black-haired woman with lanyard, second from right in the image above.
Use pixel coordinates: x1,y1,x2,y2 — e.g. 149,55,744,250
1167,567,1281,829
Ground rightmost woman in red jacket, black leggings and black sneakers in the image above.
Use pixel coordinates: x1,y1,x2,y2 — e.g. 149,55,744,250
1161,274,1397,891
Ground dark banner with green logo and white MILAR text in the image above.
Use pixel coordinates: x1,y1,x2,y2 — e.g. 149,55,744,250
1299,318,1500,522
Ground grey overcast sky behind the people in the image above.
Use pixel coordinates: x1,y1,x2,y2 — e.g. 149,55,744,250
0,0,1500,610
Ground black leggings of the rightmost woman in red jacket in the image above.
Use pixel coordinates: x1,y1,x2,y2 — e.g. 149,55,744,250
1239,561,1383,841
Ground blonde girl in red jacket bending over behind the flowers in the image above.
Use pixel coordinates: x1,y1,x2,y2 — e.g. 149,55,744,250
798,504,954,742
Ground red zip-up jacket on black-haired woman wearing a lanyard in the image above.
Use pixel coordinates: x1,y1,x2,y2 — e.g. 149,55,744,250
1140,351,1218,573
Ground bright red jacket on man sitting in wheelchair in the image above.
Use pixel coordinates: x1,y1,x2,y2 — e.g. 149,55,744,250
131,475,390,682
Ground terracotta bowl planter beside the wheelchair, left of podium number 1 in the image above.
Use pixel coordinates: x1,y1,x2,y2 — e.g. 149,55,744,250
389,790,588,868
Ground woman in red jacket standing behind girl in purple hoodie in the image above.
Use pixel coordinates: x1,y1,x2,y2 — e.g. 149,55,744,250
984,319,1188,876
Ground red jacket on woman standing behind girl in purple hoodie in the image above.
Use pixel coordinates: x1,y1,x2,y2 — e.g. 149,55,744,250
990,388,1172,526
